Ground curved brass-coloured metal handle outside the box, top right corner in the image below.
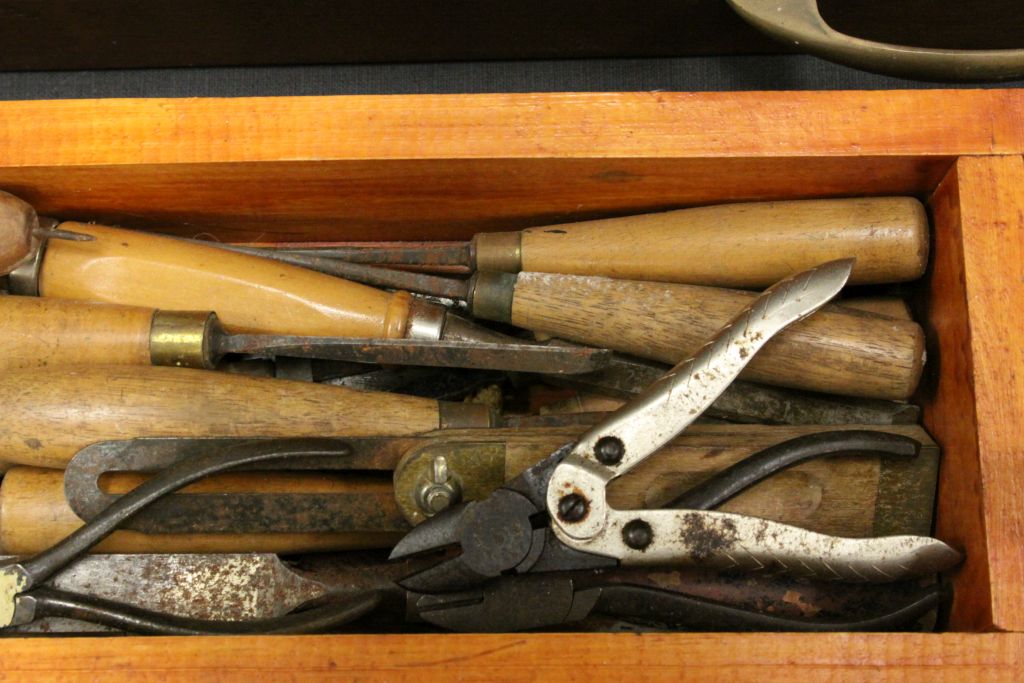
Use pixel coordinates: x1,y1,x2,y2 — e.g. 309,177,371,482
728,0,1024,82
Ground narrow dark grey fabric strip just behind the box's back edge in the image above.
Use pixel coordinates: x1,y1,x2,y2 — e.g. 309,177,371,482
0,55,1024,99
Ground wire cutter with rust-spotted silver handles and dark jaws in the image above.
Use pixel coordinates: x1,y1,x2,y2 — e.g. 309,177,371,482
391,259,961,593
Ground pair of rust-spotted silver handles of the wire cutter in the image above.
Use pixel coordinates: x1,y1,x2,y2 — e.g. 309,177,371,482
547,259,961,582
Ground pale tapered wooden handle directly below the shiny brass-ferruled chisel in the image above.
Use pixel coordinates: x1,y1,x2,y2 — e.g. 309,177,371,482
0,366,439,468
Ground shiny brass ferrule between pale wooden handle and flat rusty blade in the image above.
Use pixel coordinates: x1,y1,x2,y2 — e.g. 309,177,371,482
150,310,220,370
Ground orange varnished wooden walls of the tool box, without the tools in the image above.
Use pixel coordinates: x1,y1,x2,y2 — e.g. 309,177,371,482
0,90,1024,682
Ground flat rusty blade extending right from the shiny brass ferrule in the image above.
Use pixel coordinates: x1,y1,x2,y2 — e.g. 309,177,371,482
215,335,611,375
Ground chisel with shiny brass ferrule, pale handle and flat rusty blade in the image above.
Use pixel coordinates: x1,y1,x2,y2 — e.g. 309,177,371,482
0,296,611,374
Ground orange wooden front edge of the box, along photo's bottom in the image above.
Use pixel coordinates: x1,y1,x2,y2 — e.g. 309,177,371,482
0,633,1024,683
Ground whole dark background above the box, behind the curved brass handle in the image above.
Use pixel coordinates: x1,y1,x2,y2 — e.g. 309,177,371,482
0,0,1024,99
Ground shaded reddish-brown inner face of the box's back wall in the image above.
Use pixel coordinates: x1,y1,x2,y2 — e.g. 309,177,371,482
0,156,953,242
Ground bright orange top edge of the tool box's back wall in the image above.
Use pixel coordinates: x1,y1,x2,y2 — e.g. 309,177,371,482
0,90,1024,167
